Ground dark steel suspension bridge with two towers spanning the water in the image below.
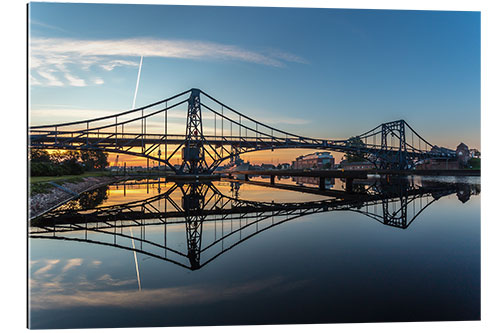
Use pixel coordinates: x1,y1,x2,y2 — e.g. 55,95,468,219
29,89,456,174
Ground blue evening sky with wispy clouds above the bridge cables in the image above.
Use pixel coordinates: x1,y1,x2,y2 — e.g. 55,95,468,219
30,3,480,148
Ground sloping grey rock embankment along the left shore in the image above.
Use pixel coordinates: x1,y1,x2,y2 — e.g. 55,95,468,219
29,177,118,219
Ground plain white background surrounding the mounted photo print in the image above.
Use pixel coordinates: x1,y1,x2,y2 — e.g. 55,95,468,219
0,0,500,333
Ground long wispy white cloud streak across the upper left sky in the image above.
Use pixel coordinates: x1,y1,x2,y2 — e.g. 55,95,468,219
30,37,307,87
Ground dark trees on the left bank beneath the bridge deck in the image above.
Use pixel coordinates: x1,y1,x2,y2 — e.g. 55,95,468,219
29,149,108,177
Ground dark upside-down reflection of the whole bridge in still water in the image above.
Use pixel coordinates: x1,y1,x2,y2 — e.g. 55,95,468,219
29,178,480,270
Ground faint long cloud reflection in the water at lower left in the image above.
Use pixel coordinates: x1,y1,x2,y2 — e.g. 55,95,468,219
30,274,306,310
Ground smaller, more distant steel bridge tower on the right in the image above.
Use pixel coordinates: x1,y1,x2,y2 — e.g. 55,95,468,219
381,120,410,170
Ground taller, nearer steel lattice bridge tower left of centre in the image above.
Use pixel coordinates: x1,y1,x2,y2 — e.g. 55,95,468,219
178,89,208,174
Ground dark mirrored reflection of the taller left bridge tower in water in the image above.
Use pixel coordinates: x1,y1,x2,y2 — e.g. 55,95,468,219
181,184,206,269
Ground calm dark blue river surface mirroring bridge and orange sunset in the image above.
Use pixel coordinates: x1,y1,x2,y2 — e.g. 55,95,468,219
29,177,480,328
